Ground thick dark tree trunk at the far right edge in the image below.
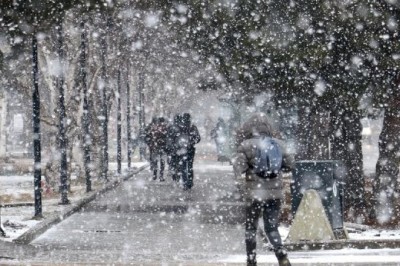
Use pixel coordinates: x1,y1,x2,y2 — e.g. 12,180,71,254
370,87,400,224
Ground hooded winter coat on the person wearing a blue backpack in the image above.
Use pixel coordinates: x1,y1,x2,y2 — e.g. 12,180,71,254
233,114,294,200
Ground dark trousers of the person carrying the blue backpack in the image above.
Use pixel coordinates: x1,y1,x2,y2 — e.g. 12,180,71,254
245,200,282,261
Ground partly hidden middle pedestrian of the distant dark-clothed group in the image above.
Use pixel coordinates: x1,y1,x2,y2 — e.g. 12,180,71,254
166,114,182,181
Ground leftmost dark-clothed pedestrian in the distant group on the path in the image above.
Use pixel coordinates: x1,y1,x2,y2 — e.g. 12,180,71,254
146,117,168,181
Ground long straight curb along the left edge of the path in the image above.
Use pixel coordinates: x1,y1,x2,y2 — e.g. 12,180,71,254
13,164,148,245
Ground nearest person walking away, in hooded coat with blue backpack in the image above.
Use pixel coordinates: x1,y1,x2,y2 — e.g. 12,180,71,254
233,113,293,266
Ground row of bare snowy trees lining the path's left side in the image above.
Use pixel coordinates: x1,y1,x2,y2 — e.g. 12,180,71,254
1,1,214,216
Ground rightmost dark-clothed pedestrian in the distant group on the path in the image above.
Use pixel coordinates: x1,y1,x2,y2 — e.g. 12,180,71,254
174,113,201,190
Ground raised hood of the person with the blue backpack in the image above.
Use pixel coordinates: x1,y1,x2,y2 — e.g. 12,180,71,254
236,113,279,145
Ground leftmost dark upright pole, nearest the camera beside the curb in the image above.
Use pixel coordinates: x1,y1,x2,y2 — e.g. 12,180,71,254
32,32,43,218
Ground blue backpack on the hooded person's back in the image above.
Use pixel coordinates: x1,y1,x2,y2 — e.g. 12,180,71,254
253,137,283,178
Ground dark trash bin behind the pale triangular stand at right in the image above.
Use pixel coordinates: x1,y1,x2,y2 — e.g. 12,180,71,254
290,160,346,238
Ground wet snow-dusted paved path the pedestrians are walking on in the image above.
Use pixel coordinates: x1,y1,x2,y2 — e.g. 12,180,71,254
0,161,400,265
